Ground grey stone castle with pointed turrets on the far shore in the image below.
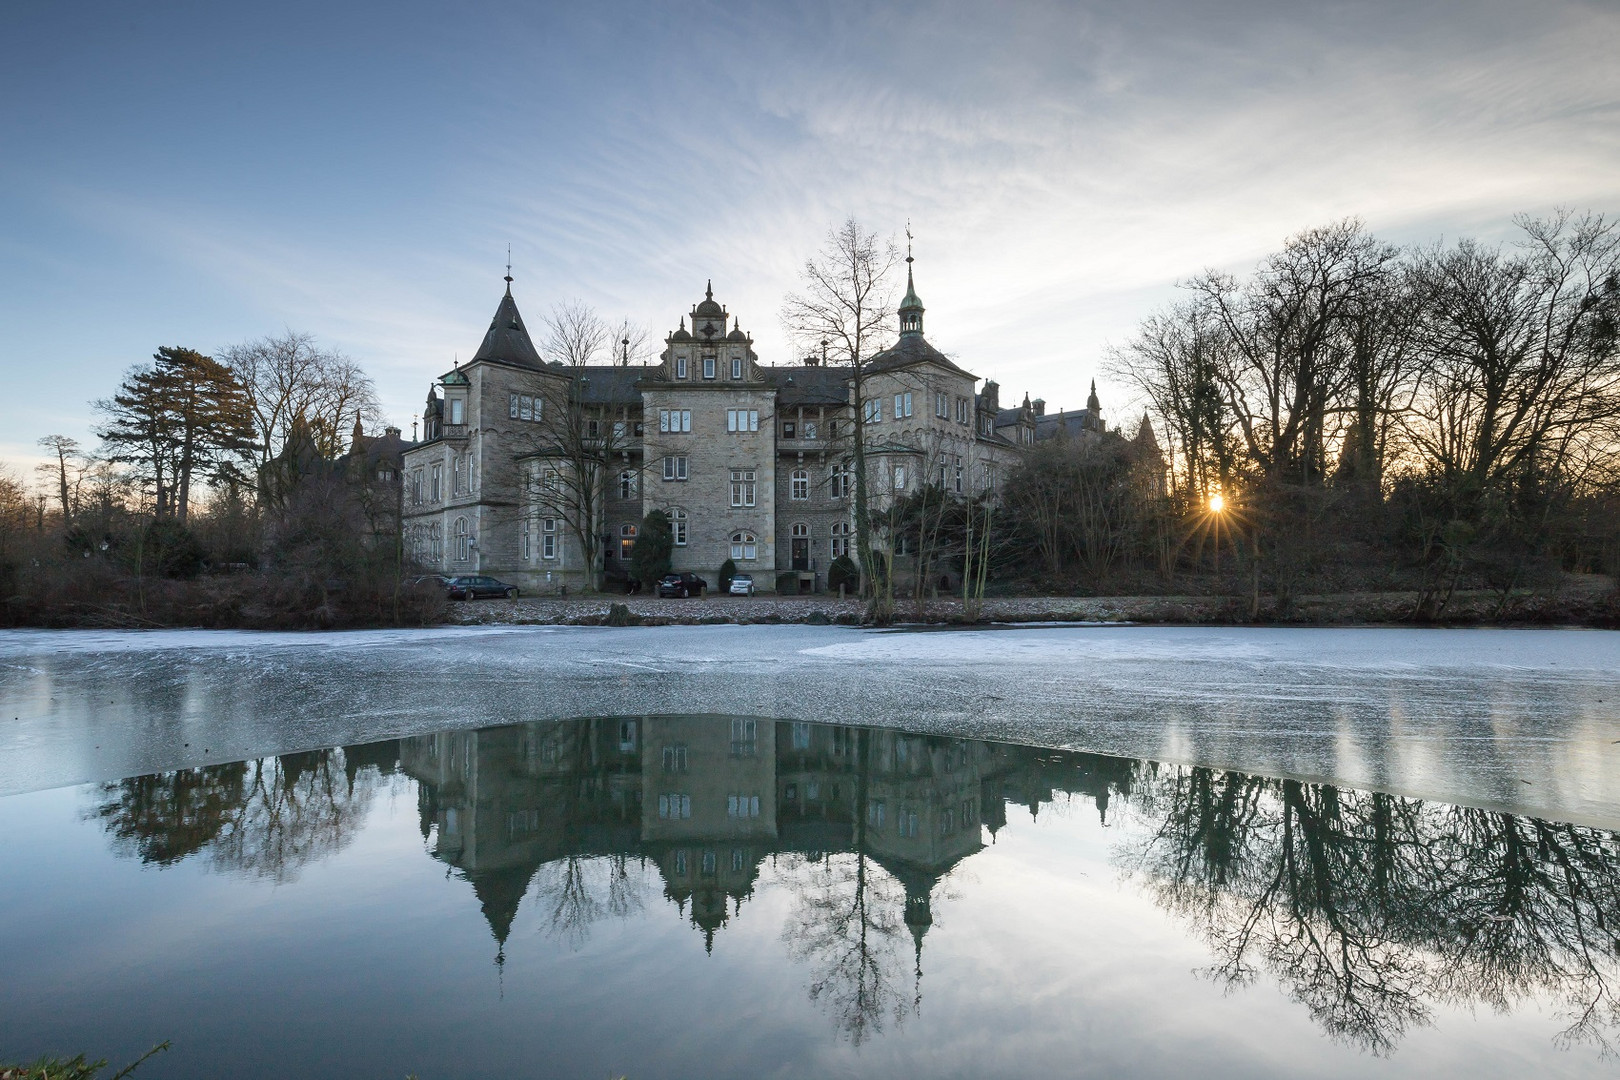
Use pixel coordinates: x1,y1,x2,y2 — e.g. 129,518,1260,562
402,257,1103,593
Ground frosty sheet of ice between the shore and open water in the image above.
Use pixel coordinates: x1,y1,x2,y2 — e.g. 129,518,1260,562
0,625,1620,827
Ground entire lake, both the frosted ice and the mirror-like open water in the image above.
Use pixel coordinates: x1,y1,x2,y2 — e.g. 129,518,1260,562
0,625,1620,1080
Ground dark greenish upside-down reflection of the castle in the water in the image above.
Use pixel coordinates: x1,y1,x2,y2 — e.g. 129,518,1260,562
400,716,1134,952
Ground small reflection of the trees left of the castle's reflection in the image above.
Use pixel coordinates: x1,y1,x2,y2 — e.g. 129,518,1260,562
92,750,379,882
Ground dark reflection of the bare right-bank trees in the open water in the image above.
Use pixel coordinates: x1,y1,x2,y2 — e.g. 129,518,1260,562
1121,769,1620,1054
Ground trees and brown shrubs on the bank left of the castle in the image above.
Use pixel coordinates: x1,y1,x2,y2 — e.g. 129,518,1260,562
0,330,437,627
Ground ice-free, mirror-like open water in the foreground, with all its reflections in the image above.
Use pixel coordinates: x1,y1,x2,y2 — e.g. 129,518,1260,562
0,717,1620,1077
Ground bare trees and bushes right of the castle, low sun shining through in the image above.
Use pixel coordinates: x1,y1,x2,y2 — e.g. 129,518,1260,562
899,214,1620,619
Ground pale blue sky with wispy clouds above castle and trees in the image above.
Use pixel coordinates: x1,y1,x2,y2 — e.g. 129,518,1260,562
0,0,1620,470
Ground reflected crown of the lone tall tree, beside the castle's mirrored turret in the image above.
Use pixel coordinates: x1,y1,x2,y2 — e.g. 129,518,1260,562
781,852,915,1046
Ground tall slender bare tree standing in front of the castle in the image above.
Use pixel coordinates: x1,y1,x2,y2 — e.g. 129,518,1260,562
782,217,901,612
